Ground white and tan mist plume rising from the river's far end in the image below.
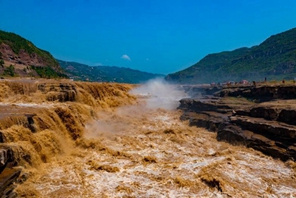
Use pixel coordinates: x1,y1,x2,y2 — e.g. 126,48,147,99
85,78,188,138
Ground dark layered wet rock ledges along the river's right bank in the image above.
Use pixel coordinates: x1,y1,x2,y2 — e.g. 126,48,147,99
179,85,296,161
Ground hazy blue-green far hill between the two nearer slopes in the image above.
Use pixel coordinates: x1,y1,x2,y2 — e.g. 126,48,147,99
57,60,164,84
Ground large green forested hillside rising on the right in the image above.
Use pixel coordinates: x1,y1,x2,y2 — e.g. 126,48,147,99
166,28,296,83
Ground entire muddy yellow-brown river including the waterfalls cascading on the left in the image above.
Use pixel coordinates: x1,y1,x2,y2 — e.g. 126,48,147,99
0,79,296,198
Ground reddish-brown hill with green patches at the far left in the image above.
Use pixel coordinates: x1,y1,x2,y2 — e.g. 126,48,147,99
0,30,67,78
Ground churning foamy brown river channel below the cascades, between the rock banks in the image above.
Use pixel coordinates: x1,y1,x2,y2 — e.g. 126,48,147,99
19,104,296,197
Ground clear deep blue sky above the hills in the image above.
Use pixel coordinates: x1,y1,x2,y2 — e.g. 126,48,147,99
0,0,296,74
